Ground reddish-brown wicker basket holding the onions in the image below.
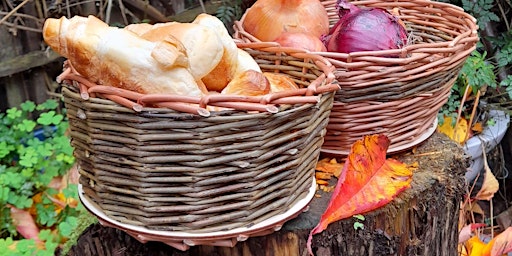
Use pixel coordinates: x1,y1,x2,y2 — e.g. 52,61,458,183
234,0,479,155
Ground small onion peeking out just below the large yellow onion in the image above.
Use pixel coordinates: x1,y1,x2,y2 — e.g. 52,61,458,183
274,32,327,52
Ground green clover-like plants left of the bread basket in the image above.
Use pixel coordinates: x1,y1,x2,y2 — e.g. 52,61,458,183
0,100,83,255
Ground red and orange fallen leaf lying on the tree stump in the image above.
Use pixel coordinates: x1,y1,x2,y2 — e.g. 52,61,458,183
307,134,412,255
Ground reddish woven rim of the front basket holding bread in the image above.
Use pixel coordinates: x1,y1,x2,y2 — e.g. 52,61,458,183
57,39,340,117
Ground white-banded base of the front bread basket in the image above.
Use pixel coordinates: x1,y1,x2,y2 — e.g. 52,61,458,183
78,179,316,251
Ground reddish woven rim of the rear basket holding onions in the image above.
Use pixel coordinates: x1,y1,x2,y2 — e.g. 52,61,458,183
233,0,479,62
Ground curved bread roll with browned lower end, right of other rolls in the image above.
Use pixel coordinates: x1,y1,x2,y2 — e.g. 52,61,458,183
192,13,238,92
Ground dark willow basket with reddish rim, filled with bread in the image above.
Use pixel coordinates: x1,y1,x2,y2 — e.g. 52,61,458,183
58,43,339,233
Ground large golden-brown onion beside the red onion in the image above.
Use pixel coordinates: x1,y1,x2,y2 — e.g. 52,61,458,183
242,0,329,42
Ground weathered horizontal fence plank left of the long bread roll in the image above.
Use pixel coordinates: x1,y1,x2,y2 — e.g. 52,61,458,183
0,50,61,77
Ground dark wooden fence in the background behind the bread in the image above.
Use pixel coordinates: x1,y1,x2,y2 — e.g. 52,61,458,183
0,0,208,112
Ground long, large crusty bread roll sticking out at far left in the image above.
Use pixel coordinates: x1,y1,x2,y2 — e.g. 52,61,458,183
43,16,202,97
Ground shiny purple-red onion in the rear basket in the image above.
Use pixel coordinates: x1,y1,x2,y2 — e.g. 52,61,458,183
322,0,407,53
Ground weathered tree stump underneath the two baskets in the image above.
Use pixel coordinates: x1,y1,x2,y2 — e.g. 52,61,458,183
68,133,469,256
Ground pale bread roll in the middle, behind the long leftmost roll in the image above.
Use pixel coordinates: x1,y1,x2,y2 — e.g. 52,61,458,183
137,22,224,79
